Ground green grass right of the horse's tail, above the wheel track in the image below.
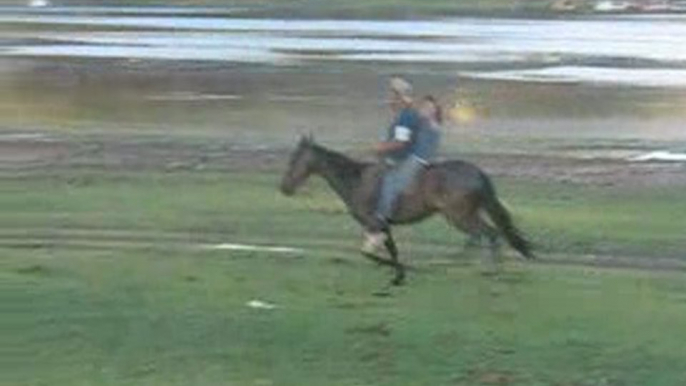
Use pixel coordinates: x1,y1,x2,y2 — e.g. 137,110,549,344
502,183,686,257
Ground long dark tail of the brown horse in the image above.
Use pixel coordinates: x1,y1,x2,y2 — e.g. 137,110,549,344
482,174,535,259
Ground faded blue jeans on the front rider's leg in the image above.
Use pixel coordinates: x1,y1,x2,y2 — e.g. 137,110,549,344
376,155,424,222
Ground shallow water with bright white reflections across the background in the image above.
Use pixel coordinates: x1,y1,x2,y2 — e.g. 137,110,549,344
0,7,686,87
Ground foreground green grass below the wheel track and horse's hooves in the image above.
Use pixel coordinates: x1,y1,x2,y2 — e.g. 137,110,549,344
0,243,686,386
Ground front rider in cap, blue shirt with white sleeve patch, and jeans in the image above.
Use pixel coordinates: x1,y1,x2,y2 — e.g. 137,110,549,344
362,77,425,255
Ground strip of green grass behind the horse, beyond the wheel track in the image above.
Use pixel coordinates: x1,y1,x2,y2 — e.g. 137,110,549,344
0,172,686,258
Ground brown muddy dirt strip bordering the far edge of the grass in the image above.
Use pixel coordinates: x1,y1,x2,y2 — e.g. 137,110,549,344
0,132,686,187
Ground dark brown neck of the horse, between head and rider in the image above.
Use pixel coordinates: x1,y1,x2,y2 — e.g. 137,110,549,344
318,149,365,206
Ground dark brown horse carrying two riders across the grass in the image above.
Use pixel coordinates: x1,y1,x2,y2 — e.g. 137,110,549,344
281,137,534,285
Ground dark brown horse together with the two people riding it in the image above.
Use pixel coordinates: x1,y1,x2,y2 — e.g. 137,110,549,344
280,78,534,285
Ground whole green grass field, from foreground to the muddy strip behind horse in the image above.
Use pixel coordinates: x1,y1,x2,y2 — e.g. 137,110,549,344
0,170,686,386
